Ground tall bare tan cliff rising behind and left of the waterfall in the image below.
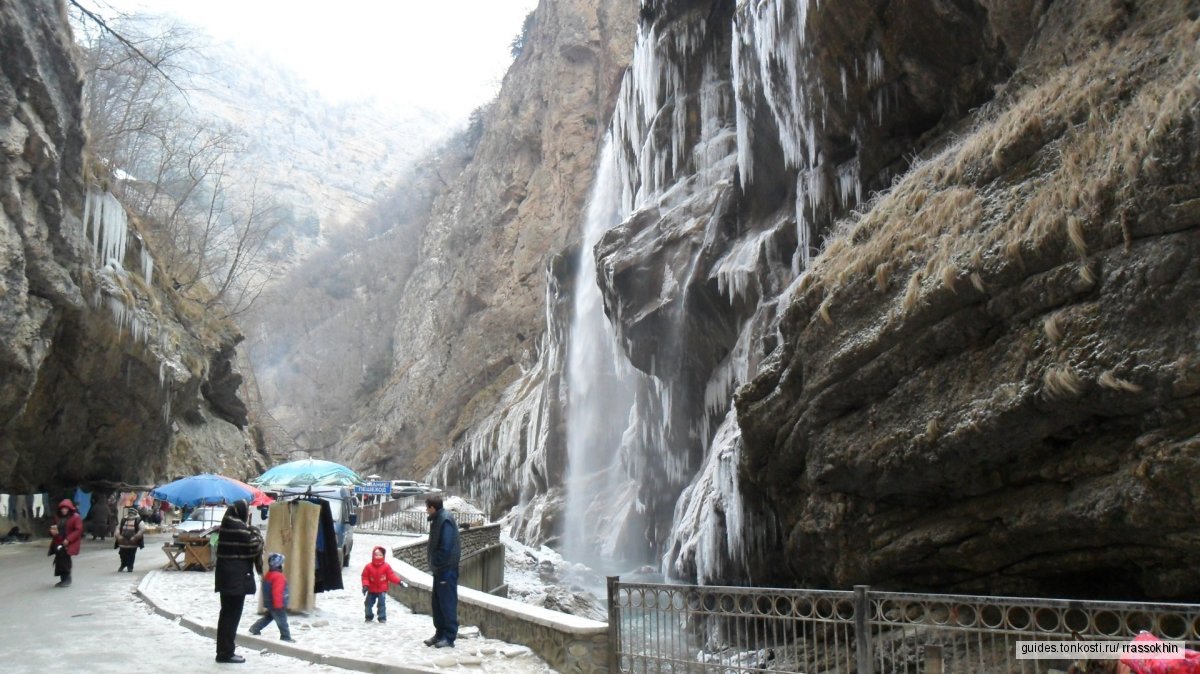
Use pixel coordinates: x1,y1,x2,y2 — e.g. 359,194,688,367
340,0,636,493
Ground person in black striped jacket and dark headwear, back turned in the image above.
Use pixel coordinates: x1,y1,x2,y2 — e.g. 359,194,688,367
215,500,263,662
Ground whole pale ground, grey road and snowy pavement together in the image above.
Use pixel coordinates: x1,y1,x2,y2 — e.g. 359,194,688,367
0,534,553,674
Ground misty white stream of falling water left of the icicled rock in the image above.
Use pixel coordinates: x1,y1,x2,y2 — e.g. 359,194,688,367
564,140,635,566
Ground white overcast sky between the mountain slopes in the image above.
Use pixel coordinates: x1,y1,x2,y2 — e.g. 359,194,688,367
91,0,538,116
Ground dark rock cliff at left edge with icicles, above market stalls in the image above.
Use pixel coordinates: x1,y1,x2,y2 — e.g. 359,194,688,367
0,1,262,493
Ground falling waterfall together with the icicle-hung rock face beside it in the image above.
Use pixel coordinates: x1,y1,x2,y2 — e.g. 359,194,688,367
530,0,888,583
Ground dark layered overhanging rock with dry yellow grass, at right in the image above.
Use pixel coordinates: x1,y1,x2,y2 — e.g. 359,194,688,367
737,1,1200,597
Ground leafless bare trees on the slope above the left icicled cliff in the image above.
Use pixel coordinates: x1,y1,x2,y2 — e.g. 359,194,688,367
72,2,287,317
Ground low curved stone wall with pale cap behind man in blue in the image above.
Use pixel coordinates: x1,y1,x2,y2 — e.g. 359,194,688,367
389,524,608,674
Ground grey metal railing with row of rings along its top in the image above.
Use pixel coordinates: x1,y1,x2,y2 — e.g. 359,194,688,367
608,578,1200,674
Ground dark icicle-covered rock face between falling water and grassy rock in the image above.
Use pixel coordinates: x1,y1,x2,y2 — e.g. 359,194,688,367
568,0,1032,582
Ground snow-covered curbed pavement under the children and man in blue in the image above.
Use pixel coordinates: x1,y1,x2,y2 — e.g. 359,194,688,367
142,530,553,674
